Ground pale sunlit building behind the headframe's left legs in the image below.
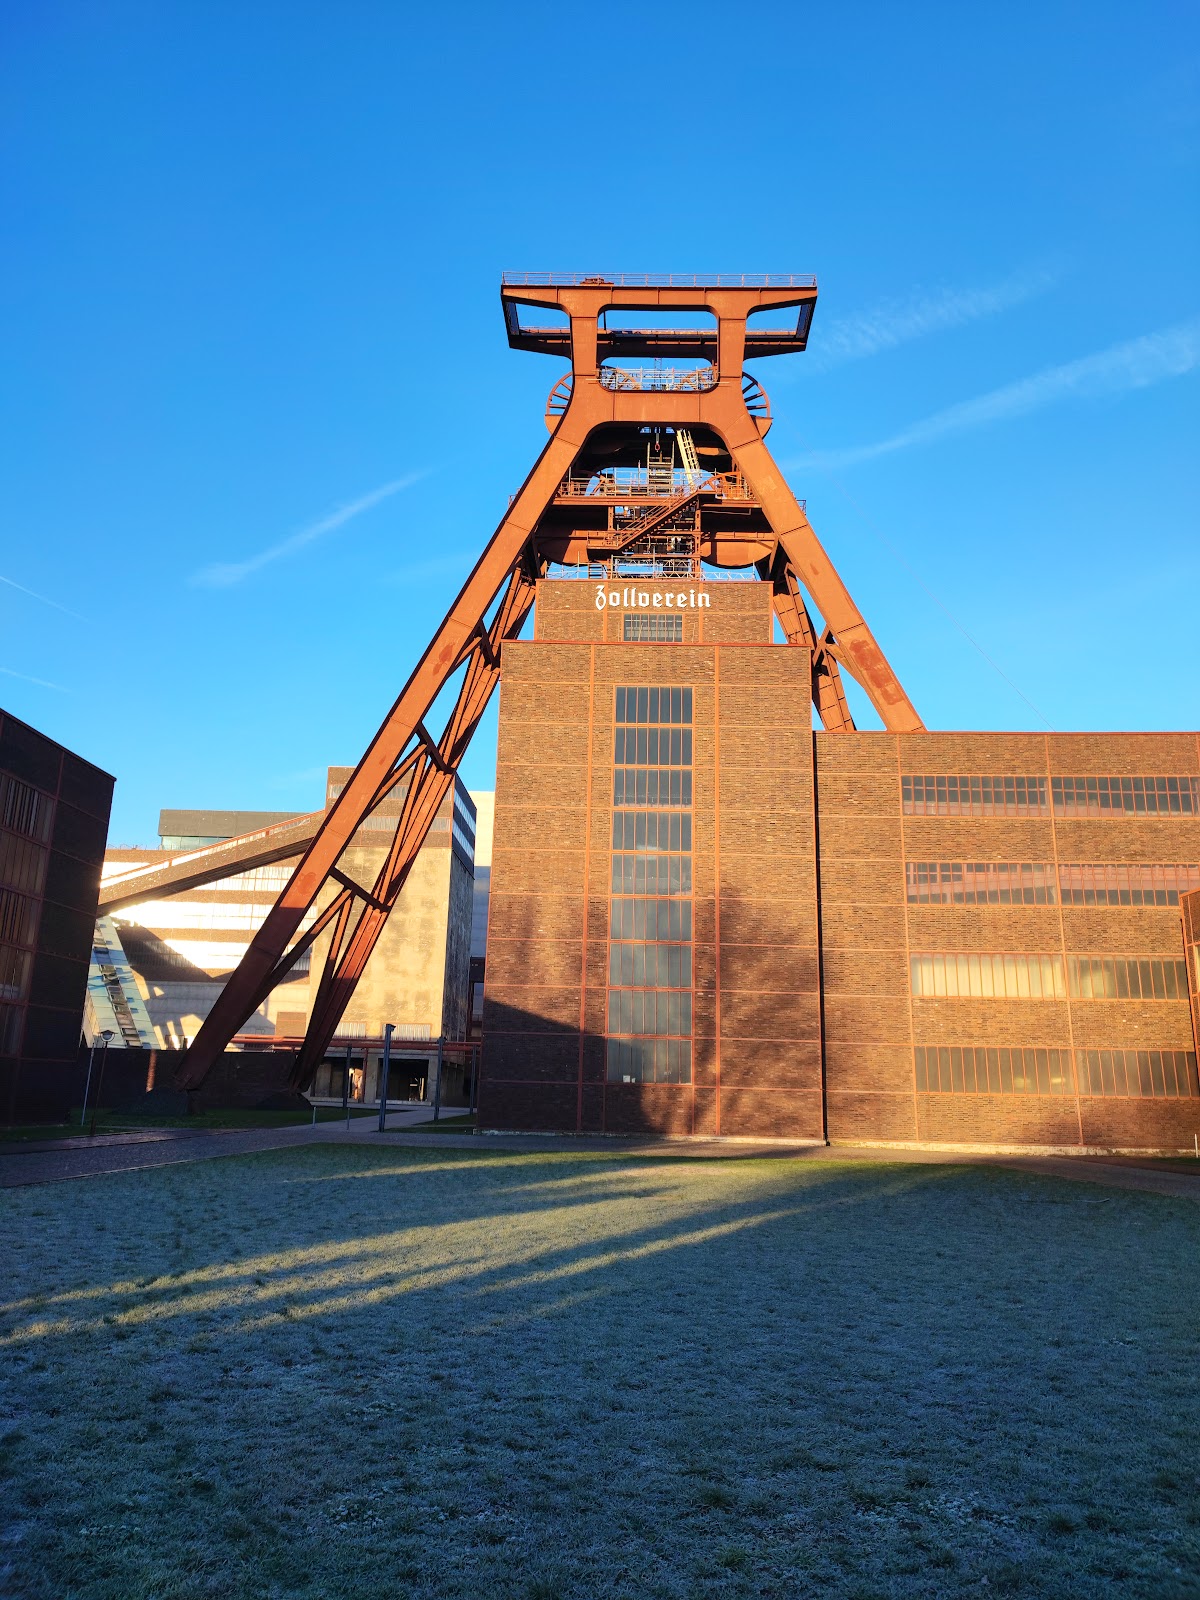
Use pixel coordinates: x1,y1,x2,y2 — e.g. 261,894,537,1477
91,766,486,1099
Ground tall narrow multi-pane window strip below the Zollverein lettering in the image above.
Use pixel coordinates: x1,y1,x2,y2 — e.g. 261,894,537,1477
608,688,691,1083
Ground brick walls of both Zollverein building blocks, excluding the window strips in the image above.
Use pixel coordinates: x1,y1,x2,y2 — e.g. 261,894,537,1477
480,579,1200,1149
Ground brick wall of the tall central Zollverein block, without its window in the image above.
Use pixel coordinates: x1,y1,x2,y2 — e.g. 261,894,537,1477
480,581,822,1139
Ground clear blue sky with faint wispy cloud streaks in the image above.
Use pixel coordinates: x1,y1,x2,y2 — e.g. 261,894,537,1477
0,0,1200,843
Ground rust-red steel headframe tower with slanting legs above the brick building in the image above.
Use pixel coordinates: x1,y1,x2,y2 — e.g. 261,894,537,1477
176,274,922,1088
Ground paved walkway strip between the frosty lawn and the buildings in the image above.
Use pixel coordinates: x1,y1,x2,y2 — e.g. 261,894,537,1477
0,1106,1200,1200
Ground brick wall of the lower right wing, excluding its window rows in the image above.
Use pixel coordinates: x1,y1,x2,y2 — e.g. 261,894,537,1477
816,733,1200,1147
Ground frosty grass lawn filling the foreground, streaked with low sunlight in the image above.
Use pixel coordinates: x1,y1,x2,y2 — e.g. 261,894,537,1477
0,1146,1200,1600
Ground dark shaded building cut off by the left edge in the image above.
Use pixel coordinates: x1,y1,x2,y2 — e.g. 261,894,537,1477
0,710,114,1123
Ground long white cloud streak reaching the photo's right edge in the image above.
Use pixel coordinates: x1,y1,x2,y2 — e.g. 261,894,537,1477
787,317,1200,470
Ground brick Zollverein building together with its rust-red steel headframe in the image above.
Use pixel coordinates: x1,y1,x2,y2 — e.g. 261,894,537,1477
167,272,1200,1149
